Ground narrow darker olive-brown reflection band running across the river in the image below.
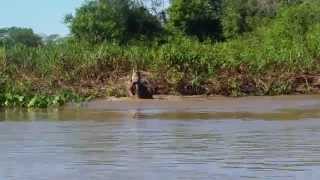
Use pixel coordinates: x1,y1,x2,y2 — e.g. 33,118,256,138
0,108,320,121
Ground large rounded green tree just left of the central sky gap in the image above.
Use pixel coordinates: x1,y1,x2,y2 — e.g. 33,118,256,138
65,0,162,43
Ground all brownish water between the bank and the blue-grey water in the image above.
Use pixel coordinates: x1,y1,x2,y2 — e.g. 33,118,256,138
0,96,320,121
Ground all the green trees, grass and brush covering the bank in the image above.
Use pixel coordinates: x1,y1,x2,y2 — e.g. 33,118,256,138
0,0,320,107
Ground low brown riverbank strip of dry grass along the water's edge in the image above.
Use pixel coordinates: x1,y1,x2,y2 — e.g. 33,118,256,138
0,62,320,108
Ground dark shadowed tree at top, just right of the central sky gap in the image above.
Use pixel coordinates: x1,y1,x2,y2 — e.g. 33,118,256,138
168,0,222,40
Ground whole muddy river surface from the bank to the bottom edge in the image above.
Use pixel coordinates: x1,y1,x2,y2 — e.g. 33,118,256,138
0,96,320,180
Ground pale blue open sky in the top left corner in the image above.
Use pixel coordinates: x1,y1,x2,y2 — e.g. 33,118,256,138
0,0,85,35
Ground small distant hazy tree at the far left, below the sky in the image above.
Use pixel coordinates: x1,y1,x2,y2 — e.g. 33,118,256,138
0,27,42,47
